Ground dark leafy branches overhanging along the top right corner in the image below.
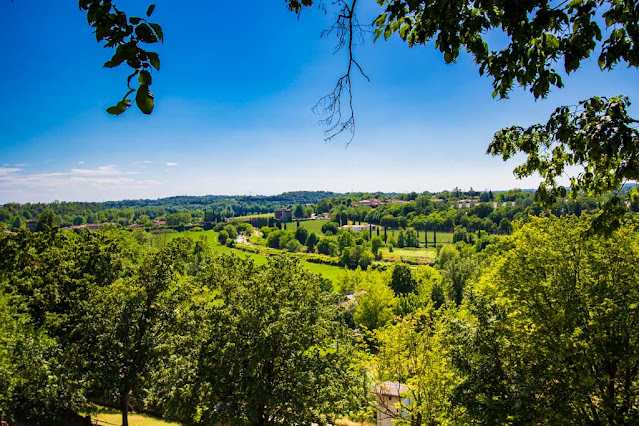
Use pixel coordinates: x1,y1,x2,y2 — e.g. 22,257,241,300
374,0,639,98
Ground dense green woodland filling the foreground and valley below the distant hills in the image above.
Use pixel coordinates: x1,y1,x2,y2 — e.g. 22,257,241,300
0,191,639,425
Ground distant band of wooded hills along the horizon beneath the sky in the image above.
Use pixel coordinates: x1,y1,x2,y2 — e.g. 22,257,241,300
0,186,639,234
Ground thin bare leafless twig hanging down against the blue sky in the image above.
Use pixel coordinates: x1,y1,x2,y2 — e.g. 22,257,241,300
313,0,371,147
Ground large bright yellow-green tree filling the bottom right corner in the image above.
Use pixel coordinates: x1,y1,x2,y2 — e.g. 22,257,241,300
448,217,639,424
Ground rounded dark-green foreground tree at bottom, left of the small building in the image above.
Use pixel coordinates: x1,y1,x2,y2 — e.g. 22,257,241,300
155,257,354,425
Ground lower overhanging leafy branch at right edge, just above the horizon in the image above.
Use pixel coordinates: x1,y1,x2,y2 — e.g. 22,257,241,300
488,96,639,225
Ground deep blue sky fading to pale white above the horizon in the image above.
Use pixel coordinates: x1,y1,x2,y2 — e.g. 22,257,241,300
0,0,639,203
